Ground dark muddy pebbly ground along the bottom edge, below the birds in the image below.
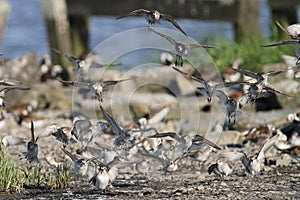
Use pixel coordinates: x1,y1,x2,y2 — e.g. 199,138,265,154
0,163,300,199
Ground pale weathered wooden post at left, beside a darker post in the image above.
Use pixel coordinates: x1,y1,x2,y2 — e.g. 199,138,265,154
41,0,71,66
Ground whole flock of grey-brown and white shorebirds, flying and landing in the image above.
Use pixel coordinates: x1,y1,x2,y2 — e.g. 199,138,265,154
0,9,300,190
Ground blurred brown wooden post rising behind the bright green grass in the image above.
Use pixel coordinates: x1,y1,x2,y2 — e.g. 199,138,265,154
235,0,261,40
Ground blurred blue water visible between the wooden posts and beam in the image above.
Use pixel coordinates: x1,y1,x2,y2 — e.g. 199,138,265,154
0,0,298,61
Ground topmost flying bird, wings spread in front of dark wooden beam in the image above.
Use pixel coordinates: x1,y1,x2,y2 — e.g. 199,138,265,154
117,9,187,35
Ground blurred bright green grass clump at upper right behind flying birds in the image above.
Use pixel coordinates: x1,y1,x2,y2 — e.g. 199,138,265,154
208,20,296,72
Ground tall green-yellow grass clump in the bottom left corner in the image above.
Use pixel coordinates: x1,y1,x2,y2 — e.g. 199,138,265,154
0,143,70,193
